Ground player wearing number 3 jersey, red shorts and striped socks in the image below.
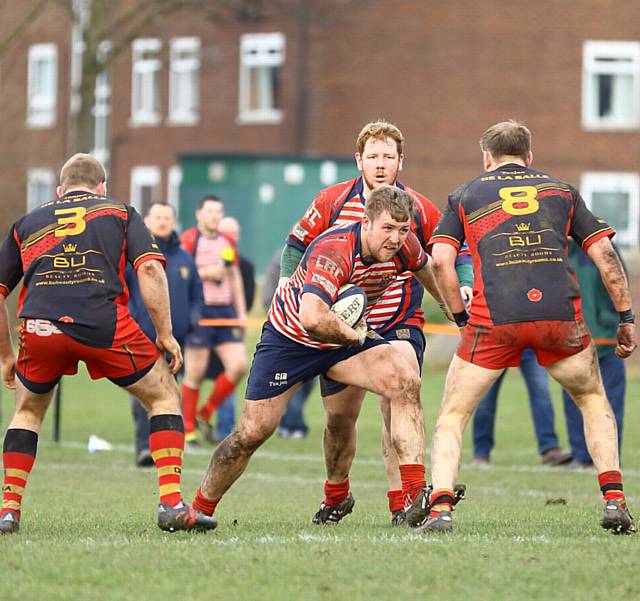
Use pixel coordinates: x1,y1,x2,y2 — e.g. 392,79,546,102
0,154,216,534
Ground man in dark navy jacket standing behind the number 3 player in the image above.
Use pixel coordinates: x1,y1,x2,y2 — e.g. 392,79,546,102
125,202,204,467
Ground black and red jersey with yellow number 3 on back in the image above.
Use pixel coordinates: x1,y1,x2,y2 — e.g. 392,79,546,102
0,192,166,348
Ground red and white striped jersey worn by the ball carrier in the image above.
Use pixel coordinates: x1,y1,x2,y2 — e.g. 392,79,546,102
268,221,427,349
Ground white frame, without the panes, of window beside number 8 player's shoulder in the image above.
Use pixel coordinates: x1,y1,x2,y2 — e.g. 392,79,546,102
580,172,640,249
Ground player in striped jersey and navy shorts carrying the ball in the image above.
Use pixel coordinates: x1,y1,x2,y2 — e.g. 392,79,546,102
193,186,431,520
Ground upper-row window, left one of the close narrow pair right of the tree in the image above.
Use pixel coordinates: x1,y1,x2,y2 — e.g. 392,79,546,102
131,38,162,125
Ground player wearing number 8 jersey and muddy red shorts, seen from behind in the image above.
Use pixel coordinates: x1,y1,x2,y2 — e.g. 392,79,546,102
419,121,636,534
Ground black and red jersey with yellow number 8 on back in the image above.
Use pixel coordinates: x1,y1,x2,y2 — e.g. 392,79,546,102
430,164,614,325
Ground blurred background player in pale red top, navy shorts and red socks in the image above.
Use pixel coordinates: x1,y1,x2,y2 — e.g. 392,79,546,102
180,195,247,444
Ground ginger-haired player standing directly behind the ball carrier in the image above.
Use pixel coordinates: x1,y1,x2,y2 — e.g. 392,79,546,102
280,120,473,525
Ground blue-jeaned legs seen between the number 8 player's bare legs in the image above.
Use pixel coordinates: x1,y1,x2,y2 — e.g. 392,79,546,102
473,349,571,466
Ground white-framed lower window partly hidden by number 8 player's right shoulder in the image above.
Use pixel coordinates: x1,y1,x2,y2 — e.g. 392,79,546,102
580,173,640,249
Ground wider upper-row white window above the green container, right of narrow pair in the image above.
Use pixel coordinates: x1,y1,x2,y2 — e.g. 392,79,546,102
238,33,285,123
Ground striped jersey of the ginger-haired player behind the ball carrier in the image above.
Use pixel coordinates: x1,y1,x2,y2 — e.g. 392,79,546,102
287,177,441,332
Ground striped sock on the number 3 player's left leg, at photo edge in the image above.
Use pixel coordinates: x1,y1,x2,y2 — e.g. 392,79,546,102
0,428,38,519
